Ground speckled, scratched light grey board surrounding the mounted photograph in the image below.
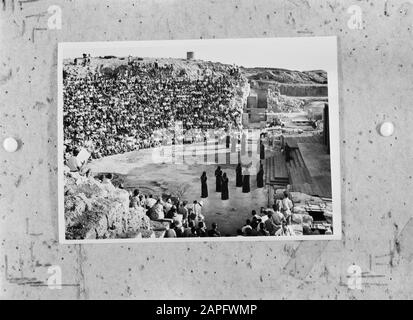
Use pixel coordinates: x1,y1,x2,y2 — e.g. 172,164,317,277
0,0,413,299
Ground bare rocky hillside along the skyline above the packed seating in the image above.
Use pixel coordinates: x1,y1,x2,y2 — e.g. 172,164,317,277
64,56,328,110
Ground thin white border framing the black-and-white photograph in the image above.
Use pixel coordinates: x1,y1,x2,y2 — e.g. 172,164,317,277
57,36,342,245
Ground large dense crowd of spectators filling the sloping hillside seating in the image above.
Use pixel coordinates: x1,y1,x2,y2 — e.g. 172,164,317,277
63,58,244,158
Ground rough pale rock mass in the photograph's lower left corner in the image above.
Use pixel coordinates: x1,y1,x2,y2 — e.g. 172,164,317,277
64,172,156,240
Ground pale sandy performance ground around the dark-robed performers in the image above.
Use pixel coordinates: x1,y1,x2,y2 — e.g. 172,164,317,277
90,140,268,235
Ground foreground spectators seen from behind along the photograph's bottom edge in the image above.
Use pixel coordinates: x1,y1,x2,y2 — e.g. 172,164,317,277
96,173,322,238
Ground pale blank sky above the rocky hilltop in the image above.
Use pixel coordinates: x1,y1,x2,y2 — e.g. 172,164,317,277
59,37,337,72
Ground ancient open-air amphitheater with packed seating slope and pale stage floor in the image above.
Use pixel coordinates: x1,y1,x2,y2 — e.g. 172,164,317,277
64,57,332,239
